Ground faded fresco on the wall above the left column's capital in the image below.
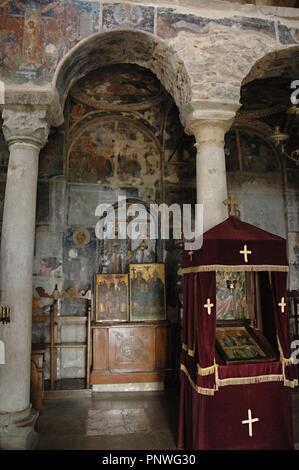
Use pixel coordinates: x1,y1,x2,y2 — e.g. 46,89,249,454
0,0,99,82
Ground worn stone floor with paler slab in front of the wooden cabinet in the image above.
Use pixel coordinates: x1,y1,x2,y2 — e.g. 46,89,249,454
37,392,299,450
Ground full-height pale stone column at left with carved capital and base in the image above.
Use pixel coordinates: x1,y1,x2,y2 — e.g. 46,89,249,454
0,108,48,449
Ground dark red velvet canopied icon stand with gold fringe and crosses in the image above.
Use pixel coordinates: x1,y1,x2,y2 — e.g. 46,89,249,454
179,217,296,449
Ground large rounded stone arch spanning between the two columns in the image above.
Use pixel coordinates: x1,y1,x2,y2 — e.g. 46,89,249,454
53,30,191,115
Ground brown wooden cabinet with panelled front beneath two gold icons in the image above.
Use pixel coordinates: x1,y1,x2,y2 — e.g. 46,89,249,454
90,321,170,385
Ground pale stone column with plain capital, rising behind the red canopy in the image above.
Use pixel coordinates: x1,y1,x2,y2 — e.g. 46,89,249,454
186,105,239,232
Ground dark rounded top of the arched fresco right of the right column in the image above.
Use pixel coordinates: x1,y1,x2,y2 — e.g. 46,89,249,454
225,130,280,173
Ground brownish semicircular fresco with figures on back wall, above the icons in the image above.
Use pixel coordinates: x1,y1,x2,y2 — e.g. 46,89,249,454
68,121,160,199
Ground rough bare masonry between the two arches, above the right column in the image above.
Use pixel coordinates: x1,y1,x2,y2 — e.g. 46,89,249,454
171,25,277,111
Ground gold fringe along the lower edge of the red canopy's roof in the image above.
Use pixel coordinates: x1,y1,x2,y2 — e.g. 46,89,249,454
182,264,289,274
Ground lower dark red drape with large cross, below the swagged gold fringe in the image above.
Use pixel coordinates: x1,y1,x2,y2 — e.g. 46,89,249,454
178,375,293,450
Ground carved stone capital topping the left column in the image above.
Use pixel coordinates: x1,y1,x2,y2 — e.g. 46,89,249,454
2,108,49,149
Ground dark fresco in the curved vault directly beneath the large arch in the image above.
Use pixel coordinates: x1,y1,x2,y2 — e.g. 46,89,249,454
72,64,164,110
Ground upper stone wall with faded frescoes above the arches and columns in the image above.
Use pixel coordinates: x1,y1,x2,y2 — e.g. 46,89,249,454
0,0,299,114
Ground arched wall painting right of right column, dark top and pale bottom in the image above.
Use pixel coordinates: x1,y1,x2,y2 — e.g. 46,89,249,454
225,125,287,238
